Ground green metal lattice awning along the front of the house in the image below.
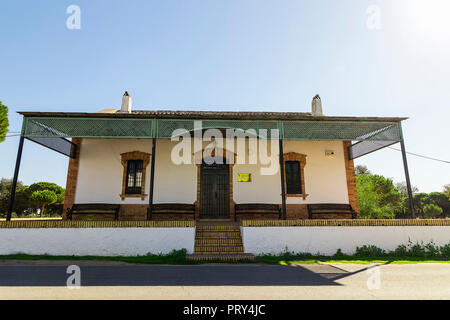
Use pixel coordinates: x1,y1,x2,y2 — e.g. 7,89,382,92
22,113,404,141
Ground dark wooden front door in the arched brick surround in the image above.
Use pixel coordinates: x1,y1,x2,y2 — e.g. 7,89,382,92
200,163,230,219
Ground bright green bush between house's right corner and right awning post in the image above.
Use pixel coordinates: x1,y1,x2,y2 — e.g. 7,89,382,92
356,174,403,219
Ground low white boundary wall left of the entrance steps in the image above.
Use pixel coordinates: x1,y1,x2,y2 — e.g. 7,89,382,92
0,228,195,256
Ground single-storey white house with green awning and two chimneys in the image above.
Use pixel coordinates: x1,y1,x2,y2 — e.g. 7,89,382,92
8,92,414,220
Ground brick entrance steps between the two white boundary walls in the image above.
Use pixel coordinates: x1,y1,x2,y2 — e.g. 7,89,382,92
187,222,255,261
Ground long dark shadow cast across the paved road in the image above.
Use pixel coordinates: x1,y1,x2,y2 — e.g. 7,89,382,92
0,264,372,286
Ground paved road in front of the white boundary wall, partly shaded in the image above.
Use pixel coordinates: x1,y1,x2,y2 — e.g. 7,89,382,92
0,261,450,299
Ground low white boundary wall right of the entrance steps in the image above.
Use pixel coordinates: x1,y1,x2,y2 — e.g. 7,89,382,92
241,226,450,255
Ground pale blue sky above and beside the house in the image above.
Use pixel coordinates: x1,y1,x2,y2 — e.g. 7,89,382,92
0,0,450,192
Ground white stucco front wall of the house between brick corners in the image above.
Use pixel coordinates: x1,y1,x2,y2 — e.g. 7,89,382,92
75,139,348,204
